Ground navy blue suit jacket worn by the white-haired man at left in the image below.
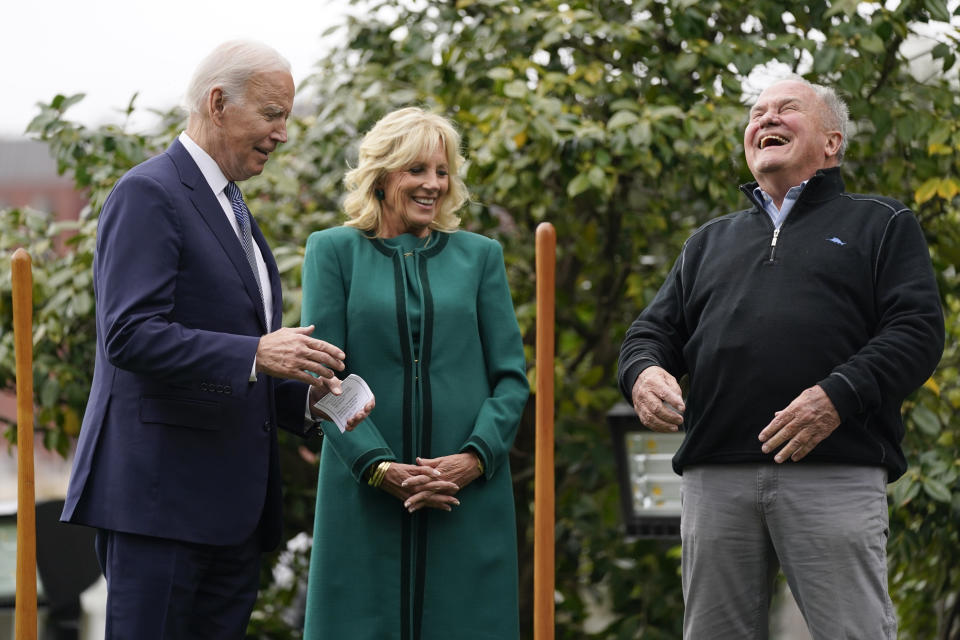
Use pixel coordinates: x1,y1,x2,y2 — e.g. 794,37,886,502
62,141,307,549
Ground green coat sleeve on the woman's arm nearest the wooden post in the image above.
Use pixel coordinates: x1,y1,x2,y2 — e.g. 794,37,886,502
461,242,530,478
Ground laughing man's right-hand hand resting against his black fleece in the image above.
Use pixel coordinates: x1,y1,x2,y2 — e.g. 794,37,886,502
759,386,840,462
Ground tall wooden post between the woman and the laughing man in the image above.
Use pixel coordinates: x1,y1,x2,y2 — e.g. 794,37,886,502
533,222,557,640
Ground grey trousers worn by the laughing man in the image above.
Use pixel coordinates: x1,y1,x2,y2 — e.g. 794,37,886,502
681,462,897,640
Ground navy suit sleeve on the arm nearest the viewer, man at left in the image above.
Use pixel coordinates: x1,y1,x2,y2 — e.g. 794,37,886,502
94,174,259,393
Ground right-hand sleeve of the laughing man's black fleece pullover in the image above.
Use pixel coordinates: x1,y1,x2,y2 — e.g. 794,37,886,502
818,210,944,419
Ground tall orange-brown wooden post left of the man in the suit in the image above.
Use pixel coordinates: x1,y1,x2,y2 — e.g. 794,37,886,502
11,249,37,640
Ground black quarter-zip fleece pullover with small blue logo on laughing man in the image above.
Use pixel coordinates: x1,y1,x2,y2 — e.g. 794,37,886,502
619,168,944,482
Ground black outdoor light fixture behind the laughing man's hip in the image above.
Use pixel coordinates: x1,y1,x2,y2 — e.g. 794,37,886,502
607,402,683,538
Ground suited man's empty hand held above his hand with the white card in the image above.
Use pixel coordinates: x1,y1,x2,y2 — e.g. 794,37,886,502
257,325,345,390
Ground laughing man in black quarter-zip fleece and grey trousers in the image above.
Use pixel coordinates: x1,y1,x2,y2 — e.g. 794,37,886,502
619,77,944,640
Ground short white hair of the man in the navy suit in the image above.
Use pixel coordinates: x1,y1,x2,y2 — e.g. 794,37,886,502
186,40,290,117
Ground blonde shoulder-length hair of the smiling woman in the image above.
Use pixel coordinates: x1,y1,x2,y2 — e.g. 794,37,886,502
343,107,470,236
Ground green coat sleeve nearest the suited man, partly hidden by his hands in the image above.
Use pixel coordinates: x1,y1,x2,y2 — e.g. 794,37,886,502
300,232,397,482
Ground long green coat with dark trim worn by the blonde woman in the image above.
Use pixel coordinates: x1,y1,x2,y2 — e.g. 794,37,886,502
302,227,529,640
